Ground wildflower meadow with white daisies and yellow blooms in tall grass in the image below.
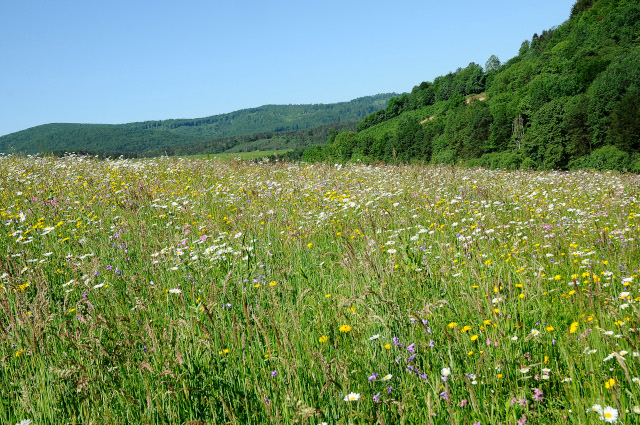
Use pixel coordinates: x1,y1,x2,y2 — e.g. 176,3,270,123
0,156,640,425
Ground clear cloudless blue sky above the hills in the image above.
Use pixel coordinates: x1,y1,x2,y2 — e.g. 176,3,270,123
0,0,575,135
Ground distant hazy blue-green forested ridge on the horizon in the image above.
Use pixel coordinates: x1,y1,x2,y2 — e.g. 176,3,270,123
0,93,396,154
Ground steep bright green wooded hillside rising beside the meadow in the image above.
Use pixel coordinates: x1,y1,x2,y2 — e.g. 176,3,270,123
312,0,640,171
